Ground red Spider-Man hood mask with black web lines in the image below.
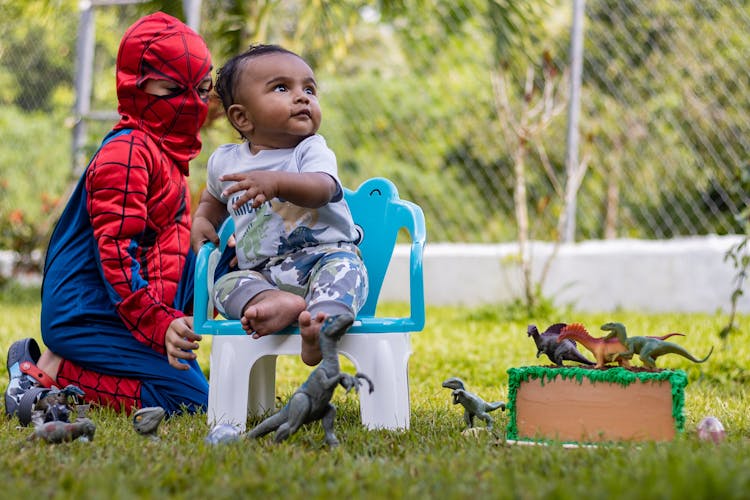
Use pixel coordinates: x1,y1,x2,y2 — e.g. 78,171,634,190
115,12,211,175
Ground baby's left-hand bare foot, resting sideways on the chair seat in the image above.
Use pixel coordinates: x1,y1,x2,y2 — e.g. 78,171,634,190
241,290,307,338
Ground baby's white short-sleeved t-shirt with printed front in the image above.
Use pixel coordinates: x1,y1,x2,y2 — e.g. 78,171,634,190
206,135,357,269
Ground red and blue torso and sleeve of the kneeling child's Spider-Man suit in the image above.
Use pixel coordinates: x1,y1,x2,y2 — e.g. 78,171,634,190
43,130,190,353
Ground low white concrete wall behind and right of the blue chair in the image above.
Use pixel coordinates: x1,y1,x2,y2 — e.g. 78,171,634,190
381,236,750,313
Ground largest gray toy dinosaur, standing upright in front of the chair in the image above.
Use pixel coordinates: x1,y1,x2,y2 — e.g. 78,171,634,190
247,314,374,446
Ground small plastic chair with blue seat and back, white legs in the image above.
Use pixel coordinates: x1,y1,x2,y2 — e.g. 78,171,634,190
194,178,426,431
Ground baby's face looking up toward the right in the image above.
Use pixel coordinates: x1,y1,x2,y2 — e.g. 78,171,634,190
230,53,322,149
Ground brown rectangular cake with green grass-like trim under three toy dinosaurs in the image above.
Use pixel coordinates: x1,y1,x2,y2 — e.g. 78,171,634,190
508,367,687,443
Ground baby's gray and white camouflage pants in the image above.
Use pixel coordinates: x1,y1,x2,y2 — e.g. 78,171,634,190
213,243,369,319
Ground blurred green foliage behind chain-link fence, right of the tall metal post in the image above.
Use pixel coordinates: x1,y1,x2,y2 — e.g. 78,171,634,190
583,0,750,238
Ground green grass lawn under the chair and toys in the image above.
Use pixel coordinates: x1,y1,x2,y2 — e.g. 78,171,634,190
0,292,750,499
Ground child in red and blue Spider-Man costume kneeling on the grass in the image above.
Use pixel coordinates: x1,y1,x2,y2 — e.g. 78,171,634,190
5,12,212,424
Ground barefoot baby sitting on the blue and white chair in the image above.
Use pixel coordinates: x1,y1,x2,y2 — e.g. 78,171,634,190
192,45,368,365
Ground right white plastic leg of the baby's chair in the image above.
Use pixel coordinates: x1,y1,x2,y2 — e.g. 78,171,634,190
339,333,411,429
